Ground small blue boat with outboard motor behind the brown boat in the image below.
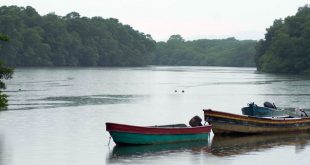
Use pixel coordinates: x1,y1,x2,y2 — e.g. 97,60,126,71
241,102,286,117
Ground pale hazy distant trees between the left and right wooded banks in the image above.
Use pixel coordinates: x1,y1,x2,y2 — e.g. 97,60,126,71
153,35,256,66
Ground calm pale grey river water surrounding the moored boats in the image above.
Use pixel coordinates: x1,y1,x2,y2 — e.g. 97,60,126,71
0,67,310,165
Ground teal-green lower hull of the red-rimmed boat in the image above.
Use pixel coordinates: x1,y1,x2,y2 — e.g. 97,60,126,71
110,132,210,145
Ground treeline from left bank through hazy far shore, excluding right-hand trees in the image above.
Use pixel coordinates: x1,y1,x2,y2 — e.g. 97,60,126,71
0,6,256,67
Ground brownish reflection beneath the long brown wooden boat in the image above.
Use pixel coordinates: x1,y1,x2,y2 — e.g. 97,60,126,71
211,133,310,156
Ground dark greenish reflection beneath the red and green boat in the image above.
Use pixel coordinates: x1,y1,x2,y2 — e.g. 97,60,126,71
109,141,210,163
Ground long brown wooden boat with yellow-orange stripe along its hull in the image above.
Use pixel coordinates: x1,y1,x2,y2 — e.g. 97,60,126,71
204,109,310,134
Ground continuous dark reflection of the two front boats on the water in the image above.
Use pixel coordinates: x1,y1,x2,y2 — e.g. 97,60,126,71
107,133,310,163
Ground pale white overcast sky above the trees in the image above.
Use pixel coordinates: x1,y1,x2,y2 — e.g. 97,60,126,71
0,0,310,41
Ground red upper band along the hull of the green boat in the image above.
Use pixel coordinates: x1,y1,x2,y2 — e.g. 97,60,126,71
106,123,212,134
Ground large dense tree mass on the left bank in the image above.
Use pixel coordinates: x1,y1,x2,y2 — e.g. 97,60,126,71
0,6,156,66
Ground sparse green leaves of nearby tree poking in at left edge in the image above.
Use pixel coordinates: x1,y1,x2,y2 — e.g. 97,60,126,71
0,34,13,109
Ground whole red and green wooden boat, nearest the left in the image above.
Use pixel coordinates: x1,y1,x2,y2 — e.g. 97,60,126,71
106,123,211,145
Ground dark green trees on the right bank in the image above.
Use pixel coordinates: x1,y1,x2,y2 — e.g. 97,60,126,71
255,5,310,74
